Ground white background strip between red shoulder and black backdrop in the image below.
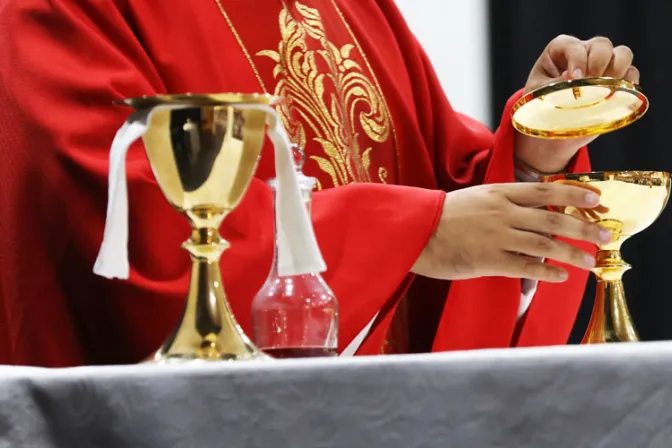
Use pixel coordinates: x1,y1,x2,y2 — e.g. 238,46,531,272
396,0,493,128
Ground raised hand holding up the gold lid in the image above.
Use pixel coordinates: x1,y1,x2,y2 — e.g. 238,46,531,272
515,35,639,173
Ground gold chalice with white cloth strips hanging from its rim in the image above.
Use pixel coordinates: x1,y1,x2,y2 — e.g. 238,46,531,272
124,94,276,362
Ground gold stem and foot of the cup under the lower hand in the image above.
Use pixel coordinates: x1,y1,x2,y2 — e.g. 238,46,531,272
582,250,639,344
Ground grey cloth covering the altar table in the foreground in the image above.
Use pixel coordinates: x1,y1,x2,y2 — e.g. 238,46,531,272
0,342,672,448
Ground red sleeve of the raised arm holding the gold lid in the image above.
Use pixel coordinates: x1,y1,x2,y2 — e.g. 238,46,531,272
360,1,595,351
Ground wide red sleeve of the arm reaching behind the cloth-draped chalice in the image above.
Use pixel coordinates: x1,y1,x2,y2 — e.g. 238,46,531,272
0,0,444,366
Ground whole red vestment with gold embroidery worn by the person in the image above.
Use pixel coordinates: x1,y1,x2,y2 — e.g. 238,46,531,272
0,0,589,366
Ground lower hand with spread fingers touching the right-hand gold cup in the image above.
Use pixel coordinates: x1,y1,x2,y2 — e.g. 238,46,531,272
412,183,611,283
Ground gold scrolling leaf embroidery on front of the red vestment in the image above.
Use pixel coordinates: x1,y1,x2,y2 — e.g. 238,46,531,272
257,2,391,186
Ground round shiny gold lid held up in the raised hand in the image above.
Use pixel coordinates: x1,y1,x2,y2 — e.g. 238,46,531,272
512,78,649,139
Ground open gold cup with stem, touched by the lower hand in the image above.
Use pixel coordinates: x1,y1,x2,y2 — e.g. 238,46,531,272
541,171,670,344
